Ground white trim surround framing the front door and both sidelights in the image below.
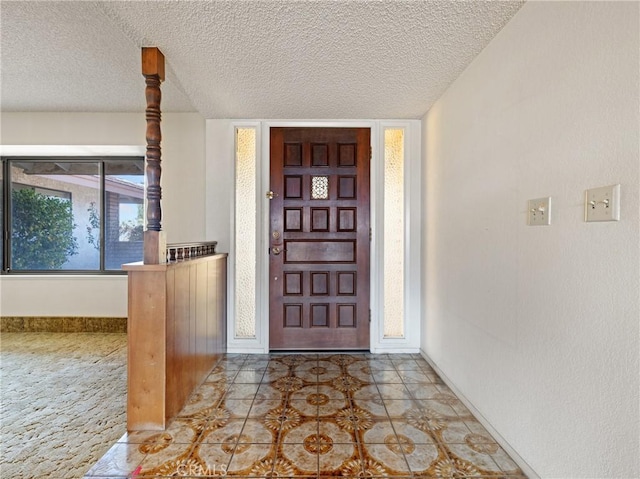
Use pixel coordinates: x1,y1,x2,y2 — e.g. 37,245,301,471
206,120,423,353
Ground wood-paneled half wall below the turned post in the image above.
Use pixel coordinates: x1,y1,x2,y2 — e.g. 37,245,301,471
123,254,227,431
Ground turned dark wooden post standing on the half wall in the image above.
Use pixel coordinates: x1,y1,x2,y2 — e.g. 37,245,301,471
142,47,166,264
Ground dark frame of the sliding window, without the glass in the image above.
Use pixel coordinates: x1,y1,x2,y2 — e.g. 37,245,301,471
0,155,146,276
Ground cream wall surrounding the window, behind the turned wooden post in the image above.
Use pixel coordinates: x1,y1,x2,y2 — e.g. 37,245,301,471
0,112,205,317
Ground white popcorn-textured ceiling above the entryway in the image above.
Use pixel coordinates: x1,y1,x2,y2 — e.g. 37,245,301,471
0,0,522,119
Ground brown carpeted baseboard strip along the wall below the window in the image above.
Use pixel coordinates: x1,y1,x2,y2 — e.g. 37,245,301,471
0,316,127,333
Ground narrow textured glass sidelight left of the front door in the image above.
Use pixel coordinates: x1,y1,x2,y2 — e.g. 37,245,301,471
235,128,256,338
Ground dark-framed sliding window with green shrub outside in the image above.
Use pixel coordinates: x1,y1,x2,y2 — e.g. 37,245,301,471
0,157,144,274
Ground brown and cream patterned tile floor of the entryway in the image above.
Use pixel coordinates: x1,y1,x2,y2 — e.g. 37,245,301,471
86,354,525,479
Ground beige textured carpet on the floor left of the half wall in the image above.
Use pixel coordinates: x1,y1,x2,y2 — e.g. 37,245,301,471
0,333,127,479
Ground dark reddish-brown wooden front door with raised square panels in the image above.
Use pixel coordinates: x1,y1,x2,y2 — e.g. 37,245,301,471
269,128,371,349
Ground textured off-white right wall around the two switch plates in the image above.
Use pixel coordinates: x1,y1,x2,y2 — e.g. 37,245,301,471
422,2,640,478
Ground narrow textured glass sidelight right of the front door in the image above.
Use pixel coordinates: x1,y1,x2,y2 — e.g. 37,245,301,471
384,128,405,338
